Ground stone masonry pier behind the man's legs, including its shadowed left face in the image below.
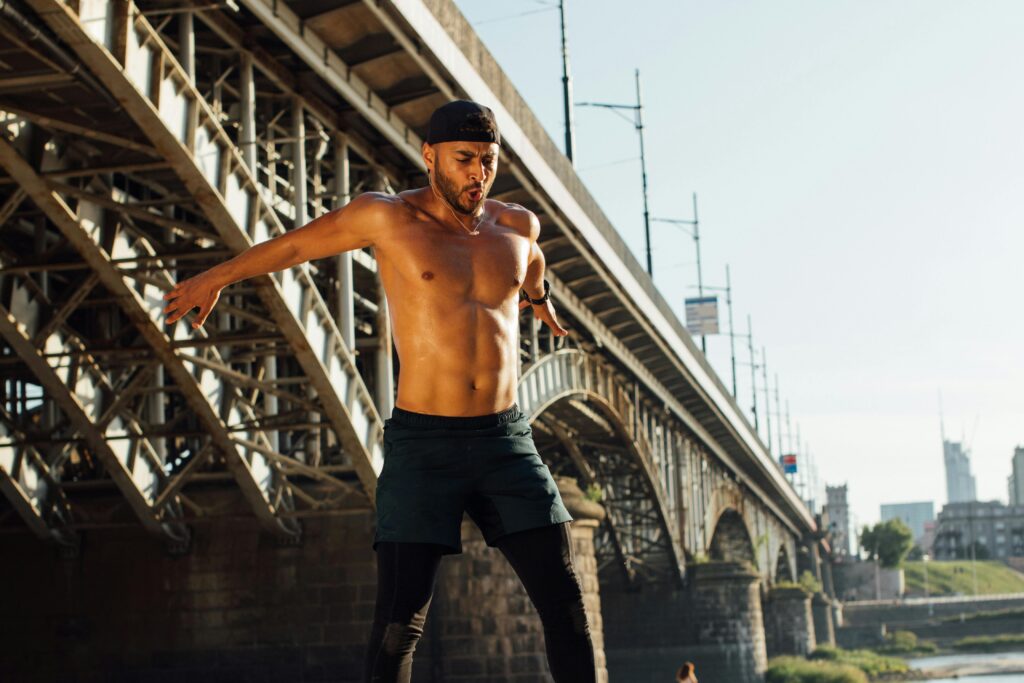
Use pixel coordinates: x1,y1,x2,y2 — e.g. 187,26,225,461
0,494,607,683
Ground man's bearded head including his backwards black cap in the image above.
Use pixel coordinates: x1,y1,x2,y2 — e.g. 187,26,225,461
423,100,501,215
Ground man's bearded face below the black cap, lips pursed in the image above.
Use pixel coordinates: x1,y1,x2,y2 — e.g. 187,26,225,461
423,142,498,215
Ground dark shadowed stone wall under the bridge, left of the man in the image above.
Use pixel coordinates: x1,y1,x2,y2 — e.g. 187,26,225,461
0,497,376,683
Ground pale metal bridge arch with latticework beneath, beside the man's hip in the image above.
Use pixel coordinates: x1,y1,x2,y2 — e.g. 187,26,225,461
518,348,685,584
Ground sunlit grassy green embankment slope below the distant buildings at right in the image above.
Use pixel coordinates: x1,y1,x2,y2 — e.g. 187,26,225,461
903,560,1024,597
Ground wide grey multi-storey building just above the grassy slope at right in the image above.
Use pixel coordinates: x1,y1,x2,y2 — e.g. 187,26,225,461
932,501,1024,560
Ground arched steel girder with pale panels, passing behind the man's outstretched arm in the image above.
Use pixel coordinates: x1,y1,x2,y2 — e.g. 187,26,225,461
29,0,383,505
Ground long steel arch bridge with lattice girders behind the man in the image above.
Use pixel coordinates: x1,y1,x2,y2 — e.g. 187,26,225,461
0,0,816,584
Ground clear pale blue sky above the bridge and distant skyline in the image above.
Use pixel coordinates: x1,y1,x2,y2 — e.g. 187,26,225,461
457,0,1024,523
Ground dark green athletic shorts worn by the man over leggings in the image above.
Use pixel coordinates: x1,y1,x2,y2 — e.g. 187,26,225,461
374,405,572,553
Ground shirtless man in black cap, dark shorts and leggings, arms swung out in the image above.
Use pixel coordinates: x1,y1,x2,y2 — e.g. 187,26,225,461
156,100,596,683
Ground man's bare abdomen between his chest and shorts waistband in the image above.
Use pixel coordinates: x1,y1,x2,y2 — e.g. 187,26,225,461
390,297,518,417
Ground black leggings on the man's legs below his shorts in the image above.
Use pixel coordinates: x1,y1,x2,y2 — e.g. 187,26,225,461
366,523,597,683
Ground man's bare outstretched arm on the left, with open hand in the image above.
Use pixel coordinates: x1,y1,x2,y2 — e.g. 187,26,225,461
164,193,388,328
